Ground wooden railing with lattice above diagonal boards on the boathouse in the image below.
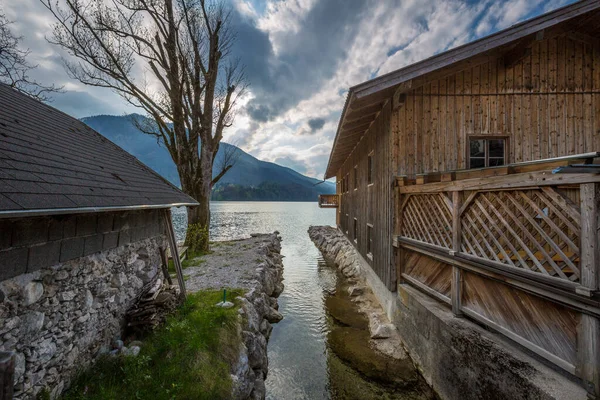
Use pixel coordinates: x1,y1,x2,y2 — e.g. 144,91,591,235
394,153,600,390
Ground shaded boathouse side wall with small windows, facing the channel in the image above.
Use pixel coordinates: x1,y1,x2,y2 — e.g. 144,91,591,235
337,103,396,291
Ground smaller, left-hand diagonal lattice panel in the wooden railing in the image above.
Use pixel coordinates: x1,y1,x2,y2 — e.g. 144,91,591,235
401,193,452,249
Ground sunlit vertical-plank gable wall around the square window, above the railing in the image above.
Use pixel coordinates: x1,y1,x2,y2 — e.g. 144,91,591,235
391,33,600,176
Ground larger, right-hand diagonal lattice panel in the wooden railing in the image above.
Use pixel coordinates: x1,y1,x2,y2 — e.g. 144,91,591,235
461,188,581,282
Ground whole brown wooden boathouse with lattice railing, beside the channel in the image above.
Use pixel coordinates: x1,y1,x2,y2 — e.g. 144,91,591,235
319,0,600,398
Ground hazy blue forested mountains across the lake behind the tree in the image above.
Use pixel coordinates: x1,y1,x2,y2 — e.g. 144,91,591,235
82,115,335,201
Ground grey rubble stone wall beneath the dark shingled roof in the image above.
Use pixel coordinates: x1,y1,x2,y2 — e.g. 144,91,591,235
0,236,166,399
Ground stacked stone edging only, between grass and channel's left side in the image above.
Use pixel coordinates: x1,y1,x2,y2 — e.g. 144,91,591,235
232,232,284,399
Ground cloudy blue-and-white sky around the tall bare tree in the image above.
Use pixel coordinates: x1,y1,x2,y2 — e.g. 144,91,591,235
0,0,572,177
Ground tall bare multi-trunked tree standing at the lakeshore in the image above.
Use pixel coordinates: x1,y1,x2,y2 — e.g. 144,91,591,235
40,0,246,251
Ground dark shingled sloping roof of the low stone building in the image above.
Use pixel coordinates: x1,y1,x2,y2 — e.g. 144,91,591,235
0,84,197,217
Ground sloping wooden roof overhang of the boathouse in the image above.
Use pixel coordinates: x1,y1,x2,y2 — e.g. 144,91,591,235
324,0,600,179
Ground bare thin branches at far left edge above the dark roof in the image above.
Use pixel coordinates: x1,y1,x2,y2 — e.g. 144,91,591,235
0,12,61,101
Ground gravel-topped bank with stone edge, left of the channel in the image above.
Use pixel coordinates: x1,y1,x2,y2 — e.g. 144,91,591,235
184,232,283,400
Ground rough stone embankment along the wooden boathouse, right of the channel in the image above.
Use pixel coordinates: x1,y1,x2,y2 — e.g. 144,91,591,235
308,226,416,381
